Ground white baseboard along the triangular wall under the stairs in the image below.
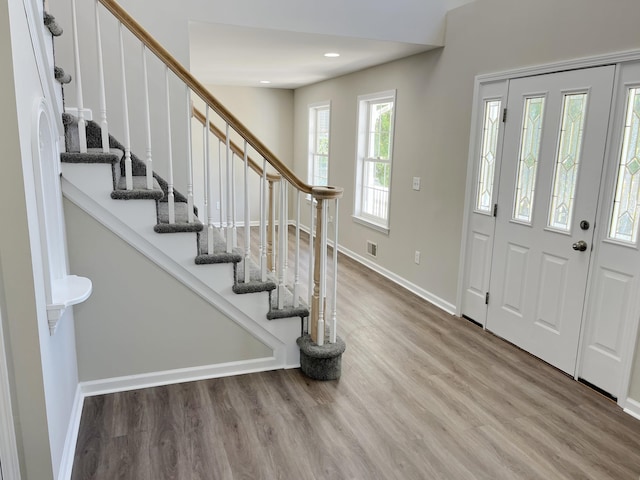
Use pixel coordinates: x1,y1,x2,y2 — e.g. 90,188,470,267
80,357,283,397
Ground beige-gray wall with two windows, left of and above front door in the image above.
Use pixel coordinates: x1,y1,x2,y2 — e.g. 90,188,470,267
294,0,640,398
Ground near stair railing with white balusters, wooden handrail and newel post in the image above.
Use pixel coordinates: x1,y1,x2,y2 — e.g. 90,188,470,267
71,0,343,345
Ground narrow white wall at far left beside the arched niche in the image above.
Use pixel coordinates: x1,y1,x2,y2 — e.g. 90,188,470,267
0,0,78,479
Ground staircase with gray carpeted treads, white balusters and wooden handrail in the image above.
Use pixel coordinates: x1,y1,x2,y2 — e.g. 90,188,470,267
45,0,344,374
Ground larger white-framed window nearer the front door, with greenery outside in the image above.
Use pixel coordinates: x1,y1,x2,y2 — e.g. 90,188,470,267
354,90,396,233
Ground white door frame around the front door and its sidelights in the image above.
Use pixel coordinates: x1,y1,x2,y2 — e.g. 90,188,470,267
455,50,640,412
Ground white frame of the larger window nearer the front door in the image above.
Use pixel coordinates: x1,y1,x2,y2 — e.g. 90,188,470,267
352,89,397,234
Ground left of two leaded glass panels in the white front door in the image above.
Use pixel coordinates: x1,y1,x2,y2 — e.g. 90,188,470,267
513,97,545,223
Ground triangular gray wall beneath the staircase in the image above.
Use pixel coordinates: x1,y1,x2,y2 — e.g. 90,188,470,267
65,201,273,381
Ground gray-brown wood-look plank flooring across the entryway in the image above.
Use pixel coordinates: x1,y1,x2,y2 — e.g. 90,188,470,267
72,231,640,480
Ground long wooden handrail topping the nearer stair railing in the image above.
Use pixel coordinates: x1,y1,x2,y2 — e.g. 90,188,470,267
99,0,342,198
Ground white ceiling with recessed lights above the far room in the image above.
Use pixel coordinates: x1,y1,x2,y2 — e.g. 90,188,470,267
189,0,471,89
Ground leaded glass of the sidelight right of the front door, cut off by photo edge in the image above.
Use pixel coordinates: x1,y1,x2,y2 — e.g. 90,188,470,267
609,87,640,243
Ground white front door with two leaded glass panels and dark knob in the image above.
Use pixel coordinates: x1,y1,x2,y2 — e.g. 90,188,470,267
486,66,615,374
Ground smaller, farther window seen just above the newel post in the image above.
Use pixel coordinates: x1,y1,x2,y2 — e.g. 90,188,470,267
308,102,331,186
